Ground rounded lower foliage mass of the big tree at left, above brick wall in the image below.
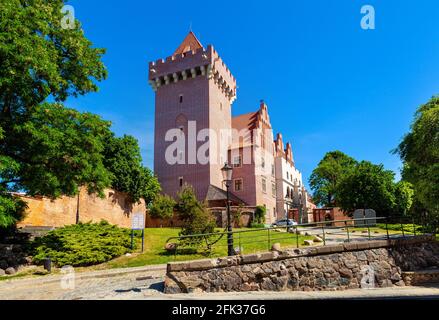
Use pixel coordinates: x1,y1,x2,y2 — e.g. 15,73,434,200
0,103,111,198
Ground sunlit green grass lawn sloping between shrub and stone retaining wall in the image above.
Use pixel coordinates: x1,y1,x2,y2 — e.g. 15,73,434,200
93,228,313,270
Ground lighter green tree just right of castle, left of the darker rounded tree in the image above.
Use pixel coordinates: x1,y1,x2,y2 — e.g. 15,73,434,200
309,151,357,207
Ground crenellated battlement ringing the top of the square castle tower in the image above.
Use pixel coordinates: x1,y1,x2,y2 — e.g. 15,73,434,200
149,45,236,103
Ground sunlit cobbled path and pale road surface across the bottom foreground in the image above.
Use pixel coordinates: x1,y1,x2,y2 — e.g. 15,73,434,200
0,270,439,300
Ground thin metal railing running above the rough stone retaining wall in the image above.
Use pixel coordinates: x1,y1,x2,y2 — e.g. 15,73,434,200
166,217,434,259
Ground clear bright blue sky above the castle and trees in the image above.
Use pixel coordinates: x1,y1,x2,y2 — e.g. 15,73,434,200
67,0,439,189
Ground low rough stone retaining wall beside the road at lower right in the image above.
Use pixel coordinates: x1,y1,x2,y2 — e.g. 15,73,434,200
165,236,439,293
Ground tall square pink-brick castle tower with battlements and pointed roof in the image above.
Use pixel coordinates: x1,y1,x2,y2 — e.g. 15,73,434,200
149,32,236,200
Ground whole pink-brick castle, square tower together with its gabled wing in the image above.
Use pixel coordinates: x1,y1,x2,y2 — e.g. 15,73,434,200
149,32,309,223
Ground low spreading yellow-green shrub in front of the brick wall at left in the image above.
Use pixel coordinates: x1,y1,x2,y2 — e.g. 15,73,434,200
32,221,131,267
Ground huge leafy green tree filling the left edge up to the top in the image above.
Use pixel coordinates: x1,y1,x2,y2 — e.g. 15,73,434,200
0,0,110,227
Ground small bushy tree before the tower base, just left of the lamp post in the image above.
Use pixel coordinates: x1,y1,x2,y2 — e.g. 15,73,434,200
175,185,216,238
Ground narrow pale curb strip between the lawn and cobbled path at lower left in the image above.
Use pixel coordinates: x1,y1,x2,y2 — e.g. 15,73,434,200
0,264,166,287
